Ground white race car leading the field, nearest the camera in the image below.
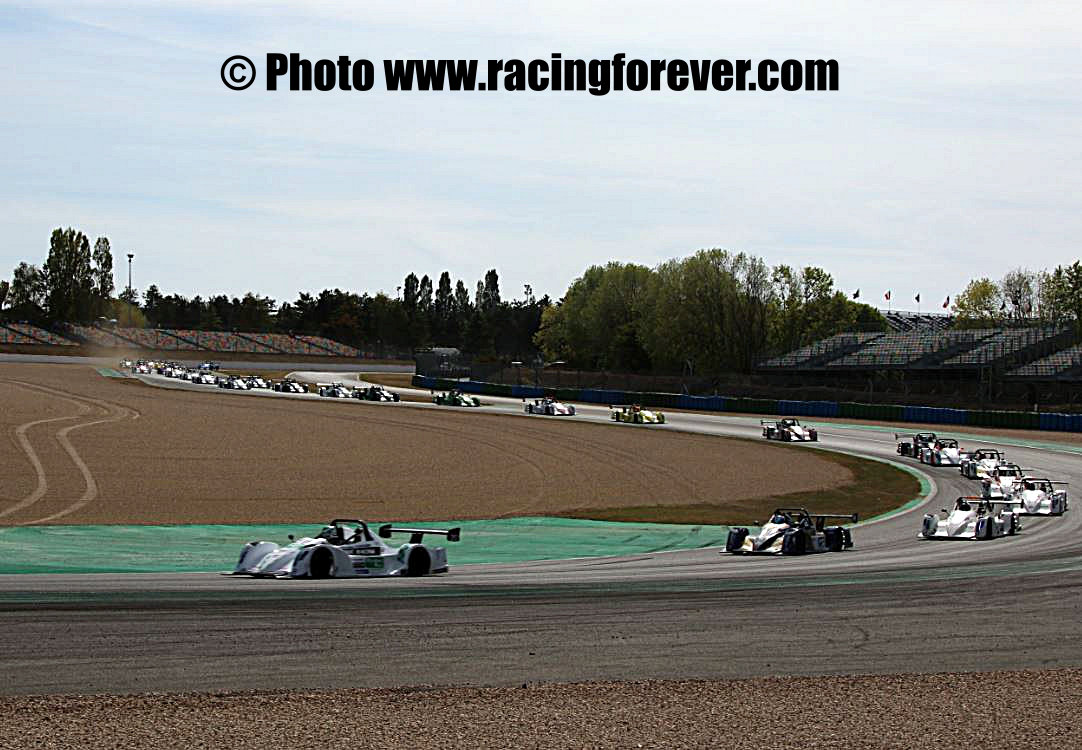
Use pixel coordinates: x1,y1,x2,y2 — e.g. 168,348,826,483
232,518,460,578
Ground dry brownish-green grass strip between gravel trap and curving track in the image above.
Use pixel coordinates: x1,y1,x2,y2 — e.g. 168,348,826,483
554,451,921,526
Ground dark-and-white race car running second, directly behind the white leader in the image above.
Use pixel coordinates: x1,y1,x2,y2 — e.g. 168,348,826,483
725,508,858,555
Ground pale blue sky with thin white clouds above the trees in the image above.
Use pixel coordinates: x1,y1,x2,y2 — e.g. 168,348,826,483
0,0,1082,311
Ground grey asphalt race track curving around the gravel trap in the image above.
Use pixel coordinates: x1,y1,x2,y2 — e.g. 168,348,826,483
0,373,1082,694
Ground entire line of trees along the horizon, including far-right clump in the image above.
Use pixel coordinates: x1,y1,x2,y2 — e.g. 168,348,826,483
8,228,1082,373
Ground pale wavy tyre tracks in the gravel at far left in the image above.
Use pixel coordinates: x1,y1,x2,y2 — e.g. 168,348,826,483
0,378,138,526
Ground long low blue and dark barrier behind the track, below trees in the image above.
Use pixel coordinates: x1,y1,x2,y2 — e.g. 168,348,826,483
412,374,1082,432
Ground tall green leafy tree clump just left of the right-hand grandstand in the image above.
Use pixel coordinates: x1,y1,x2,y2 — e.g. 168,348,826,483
535,249,886,373
